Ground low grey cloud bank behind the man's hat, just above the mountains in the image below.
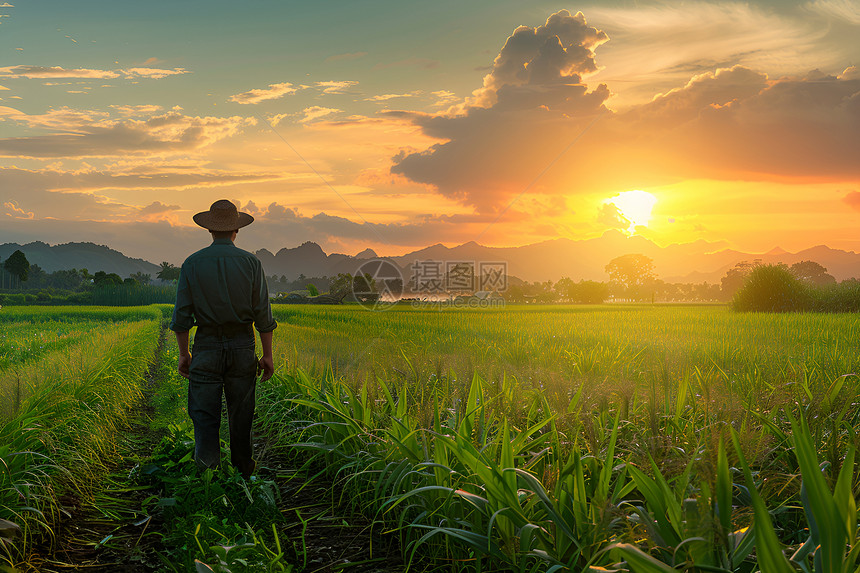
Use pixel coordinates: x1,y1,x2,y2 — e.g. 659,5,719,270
0,202,482,264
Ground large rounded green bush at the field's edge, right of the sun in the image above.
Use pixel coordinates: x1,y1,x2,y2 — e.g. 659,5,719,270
732,265,818,312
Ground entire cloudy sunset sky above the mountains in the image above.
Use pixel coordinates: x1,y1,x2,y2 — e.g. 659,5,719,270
0,0,860,263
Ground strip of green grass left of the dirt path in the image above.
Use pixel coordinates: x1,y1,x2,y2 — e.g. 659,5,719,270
0,321,159,565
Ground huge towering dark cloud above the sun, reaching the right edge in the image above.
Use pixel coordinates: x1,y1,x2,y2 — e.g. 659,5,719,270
390,10,860,210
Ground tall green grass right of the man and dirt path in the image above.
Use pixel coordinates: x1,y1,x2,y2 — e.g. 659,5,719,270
262,307,860,571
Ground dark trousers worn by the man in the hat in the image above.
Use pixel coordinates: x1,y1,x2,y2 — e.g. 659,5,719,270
188,332,257,477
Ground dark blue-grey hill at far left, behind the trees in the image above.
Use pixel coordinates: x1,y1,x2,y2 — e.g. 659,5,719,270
0,241,160,278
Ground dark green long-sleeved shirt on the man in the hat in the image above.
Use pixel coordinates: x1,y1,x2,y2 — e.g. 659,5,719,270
170,239,277,332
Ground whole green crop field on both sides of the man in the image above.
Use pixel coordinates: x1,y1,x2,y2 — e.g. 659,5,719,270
0,305,860,573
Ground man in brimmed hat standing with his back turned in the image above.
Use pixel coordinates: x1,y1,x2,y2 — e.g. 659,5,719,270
170,199,277,478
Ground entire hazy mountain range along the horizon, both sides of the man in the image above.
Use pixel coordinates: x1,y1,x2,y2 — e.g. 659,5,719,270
0,231,860,283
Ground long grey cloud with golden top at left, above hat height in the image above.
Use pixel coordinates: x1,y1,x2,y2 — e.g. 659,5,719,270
0,108,256,158
